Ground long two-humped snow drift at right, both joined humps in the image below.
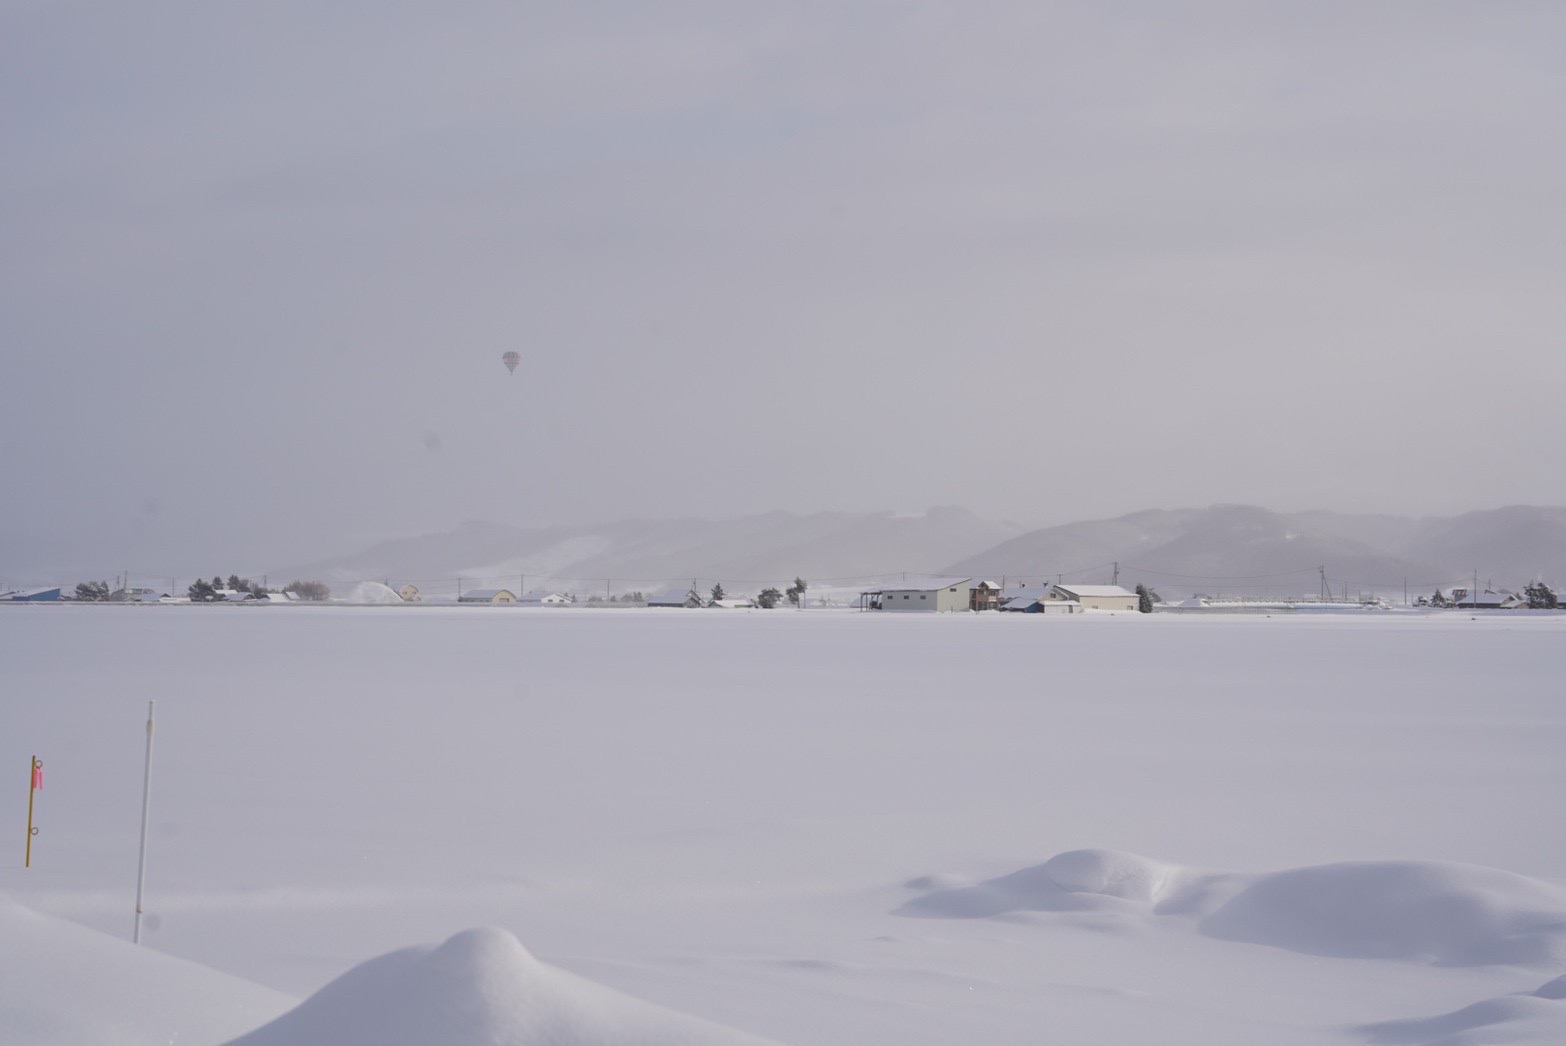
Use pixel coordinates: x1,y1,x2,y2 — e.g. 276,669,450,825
899,850,1566,966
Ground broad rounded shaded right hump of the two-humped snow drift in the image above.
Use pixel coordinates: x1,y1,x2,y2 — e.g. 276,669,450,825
1201,861,1566,966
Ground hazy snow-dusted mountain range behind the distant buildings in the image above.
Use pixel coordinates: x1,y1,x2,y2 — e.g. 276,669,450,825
271,504,1566,595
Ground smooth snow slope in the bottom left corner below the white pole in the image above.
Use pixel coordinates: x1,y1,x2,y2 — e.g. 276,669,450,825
0,897,296,1046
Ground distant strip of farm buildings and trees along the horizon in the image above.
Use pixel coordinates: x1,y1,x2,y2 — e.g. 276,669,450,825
0,575,1560,614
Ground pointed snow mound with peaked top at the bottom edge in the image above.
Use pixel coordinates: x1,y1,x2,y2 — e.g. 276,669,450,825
233,929,776,1046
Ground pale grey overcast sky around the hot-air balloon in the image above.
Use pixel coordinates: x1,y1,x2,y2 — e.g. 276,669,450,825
0,0,1566,572
